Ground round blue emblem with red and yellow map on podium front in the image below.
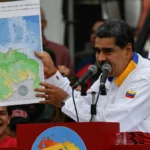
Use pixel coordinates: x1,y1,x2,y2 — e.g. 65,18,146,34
31,126,86,150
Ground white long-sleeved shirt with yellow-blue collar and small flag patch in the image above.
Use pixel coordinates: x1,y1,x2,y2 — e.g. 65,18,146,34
46,53,150,132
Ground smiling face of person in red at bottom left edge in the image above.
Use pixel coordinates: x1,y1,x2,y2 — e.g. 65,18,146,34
0,106,10,137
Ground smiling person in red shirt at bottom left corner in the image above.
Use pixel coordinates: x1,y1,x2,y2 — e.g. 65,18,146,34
0,106,17,148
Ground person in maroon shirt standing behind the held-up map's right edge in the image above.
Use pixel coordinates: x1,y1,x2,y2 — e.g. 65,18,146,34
41,8,74,75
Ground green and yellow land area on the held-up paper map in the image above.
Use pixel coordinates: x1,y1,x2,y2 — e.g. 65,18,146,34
0,50,40,99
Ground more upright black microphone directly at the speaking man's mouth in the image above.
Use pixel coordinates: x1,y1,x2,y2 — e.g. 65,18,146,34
100,63,112,86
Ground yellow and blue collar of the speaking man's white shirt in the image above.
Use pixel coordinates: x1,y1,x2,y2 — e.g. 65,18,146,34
108,52,138,86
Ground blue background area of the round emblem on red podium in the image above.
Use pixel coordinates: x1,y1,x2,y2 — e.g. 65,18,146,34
32,126,86,150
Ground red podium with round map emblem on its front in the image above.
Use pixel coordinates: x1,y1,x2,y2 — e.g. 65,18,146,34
16,122,119,150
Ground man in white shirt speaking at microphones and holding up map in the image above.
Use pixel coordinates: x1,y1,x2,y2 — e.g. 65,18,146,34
35,20,150,132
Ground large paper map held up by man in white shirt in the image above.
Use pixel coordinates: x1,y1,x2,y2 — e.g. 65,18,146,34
0,0,44,106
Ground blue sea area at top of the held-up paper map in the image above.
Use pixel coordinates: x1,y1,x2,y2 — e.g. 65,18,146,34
0,15,41,52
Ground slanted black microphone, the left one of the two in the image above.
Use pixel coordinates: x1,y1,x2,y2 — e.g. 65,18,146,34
72,65,98,89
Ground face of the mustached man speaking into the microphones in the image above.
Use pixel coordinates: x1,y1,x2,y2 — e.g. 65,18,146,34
95,37,133,77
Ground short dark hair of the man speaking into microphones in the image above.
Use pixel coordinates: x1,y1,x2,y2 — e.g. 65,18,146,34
95,19,134,51
